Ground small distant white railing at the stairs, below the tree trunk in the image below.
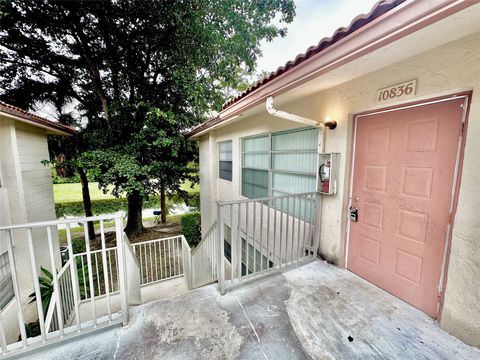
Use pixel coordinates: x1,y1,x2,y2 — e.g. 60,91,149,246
132,235,184,285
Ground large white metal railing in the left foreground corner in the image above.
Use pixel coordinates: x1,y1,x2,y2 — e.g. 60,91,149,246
0,213,133,357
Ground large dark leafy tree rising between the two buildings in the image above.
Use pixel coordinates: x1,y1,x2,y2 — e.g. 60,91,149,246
0,0,294,233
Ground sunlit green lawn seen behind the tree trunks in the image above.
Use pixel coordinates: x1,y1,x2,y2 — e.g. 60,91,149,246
53,181,200,204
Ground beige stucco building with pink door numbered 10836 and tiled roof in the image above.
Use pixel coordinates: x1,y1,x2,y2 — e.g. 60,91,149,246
190,0,480,346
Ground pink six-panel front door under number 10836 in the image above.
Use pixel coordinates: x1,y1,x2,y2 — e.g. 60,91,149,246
348,98,464,317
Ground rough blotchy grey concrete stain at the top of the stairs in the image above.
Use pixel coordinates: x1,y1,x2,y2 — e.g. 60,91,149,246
118,287,242,359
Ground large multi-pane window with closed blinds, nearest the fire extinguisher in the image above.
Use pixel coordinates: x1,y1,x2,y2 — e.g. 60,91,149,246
242,128,318,198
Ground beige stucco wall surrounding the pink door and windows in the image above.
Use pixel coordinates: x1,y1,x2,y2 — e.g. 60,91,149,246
200,33,480,346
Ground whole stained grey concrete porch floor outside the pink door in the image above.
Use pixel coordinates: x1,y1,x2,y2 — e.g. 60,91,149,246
27,261,480,360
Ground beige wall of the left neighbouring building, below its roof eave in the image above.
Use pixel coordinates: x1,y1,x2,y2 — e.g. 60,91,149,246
0,117,61,342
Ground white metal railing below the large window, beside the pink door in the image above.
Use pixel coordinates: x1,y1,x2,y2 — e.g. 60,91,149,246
216,193,318,294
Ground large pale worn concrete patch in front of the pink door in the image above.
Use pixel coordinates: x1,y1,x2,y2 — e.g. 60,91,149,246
284,262,480,359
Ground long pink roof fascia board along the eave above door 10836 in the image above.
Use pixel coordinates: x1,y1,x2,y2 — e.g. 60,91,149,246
190,0,475,139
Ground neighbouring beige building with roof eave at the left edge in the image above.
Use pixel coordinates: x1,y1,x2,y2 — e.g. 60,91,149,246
0,102,75,341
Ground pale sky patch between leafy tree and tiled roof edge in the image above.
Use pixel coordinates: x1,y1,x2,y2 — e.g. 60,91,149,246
257,0,378,73
